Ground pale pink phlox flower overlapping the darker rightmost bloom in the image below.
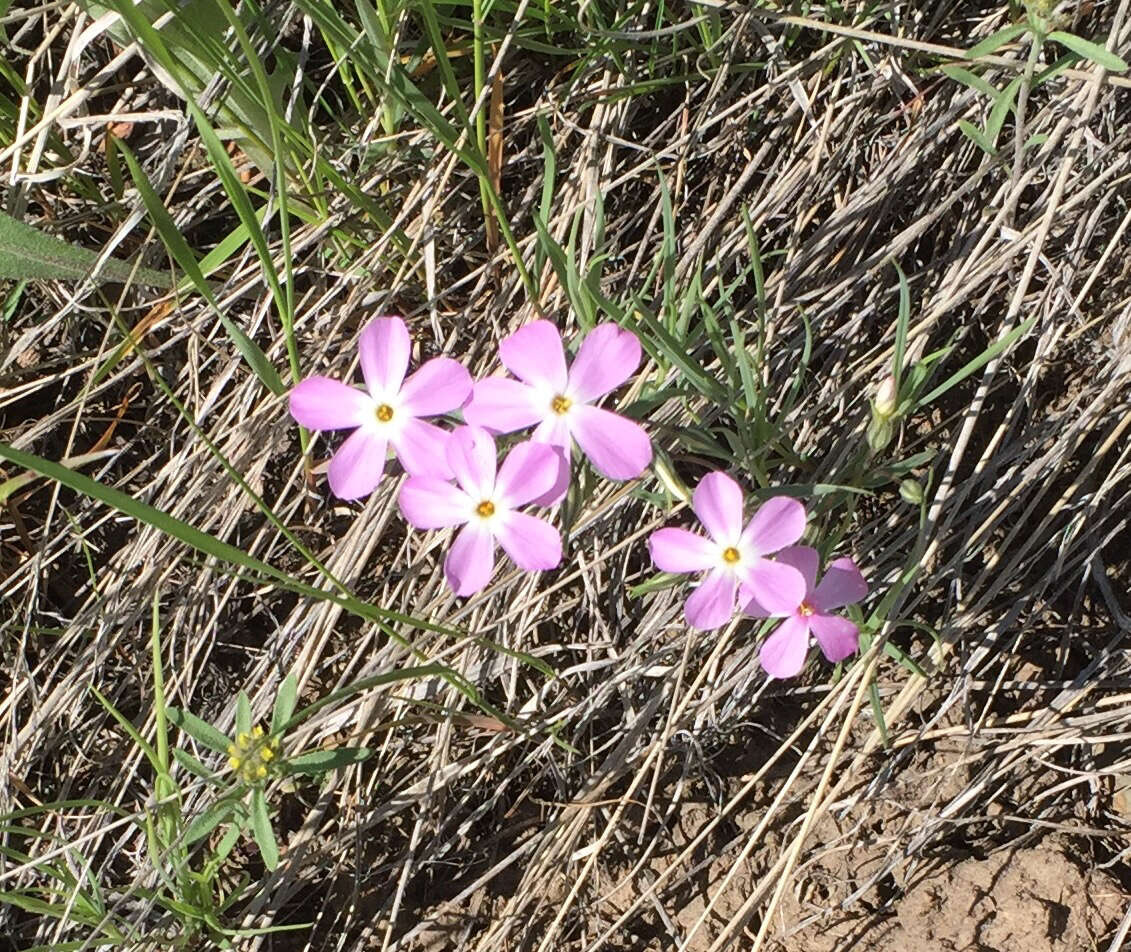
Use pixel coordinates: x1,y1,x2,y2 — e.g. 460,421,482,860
648,473,805,630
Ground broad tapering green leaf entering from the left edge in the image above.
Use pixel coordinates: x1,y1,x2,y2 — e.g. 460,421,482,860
0,211,173,281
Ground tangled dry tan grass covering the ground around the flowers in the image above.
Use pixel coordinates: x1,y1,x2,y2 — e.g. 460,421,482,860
0,0,1131,952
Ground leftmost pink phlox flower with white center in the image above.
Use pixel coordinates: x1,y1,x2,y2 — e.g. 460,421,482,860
291,318,472,499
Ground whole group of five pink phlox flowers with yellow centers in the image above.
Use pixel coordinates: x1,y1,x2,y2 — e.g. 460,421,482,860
290,317,867,677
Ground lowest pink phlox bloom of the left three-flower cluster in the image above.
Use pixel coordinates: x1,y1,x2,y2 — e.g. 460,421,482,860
399,426,562,596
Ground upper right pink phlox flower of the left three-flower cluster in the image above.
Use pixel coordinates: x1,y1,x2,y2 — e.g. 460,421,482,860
464,321,651,505
